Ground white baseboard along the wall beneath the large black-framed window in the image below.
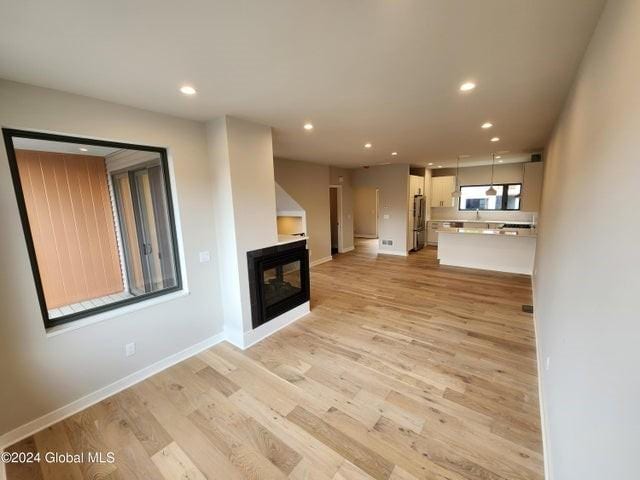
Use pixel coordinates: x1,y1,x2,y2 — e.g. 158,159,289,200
0,333,225,450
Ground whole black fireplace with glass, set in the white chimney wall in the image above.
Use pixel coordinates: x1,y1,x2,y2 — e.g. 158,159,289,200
247,240,309,328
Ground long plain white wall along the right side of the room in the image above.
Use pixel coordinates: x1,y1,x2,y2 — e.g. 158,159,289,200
534,0,640,480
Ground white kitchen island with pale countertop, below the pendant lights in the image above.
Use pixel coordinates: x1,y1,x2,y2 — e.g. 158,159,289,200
438,228,537,275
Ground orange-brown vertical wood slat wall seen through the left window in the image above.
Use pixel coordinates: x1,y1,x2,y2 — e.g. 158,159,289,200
16,150,124,309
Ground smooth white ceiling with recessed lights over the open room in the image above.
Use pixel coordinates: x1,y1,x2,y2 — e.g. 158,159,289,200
0,0,604,166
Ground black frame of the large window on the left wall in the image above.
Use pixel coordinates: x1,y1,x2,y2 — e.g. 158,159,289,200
2,128,183,329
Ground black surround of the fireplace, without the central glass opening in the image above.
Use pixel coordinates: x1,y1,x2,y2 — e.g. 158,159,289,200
247,240,310,328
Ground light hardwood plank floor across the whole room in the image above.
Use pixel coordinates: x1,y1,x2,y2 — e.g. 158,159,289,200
7,242,543,480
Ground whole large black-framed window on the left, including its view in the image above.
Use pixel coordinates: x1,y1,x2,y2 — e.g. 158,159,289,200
5,131,181,327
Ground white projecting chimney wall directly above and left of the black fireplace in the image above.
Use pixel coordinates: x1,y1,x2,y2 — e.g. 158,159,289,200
207,116,278,346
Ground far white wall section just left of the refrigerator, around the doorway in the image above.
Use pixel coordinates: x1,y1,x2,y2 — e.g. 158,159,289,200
351,165,409,255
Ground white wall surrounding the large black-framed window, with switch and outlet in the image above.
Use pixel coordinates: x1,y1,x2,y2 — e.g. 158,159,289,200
0,81,222,434
